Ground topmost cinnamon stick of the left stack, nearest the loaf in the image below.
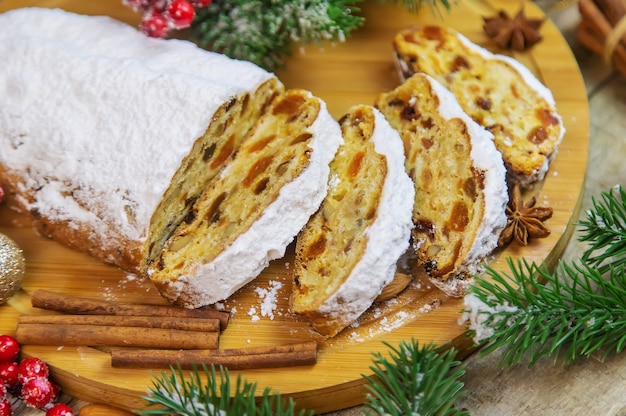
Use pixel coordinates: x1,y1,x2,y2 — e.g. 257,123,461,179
31,289,229,329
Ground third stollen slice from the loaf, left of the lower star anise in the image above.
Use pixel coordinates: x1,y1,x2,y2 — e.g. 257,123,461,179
376,73,508,296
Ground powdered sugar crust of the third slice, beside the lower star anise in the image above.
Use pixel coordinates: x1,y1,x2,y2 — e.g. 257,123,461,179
424,74,509,293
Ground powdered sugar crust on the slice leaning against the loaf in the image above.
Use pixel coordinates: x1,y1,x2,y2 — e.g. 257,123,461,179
156,95,343,308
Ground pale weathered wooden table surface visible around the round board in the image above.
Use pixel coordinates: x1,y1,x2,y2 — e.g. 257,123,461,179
6,0,626,416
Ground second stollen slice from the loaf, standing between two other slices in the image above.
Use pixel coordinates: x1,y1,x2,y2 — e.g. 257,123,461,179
291,105,414,336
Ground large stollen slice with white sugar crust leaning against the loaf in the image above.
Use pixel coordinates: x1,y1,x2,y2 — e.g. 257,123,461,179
148,90,342,307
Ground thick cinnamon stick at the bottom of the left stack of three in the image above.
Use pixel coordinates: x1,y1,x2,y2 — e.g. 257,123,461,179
15,324,219,349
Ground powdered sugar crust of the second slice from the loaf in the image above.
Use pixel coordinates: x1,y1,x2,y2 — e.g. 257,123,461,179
310,107,415,327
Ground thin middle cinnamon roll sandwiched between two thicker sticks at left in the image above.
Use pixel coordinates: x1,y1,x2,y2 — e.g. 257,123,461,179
17,315,220,332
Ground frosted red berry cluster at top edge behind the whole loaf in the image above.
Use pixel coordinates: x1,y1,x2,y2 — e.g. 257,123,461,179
122,0,212,38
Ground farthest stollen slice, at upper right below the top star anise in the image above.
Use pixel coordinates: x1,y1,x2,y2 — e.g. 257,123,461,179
393,26,565,186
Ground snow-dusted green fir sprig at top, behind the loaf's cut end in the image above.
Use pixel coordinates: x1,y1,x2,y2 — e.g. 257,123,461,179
191,0,364,69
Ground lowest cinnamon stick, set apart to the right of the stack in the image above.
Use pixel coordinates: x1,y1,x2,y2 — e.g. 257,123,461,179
111,341,317,370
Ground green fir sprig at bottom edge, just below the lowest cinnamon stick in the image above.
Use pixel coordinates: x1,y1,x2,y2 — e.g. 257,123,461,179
138,365,312,416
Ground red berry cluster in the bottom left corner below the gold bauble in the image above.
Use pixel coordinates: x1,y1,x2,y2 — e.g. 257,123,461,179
0,335,74,416
